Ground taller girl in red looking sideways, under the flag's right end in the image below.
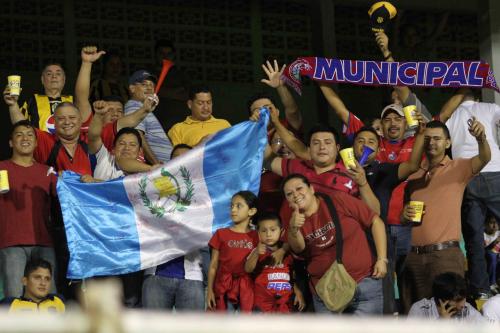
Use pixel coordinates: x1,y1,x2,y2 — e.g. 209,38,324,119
207,191,258,312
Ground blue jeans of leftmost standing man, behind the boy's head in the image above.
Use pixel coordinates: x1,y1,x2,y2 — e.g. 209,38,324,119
0,246,56,297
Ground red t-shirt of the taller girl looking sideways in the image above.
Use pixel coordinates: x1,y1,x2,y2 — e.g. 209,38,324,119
208,228,259,274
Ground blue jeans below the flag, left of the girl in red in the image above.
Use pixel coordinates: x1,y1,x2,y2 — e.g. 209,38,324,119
142,275,205,311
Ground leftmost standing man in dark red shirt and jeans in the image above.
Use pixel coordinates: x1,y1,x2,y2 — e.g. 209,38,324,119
0,120,56,297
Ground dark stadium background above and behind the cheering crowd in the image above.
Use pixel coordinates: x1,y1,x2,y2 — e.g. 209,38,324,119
0,0,480,159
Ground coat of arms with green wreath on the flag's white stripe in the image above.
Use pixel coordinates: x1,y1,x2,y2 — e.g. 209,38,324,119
139,166,194,218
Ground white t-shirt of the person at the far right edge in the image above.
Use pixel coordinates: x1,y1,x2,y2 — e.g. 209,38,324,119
446,101,500,172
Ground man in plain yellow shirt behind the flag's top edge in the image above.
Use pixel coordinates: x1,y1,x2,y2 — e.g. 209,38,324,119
168,86,231,147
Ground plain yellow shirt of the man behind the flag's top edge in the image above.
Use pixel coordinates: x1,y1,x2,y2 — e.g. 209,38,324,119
168,116,231,147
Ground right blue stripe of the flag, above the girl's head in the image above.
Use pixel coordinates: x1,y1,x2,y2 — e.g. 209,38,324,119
203,111,269,232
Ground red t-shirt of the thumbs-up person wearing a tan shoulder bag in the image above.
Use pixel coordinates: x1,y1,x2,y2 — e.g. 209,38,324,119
285,192,376,286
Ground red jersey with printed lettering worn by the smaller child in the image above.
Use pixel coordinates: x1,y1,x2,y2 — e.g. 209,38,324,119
254,252,293,313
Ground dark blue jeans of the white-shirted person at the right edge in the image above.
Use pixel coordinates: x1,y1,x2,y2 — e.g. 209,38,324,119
462,172,500,293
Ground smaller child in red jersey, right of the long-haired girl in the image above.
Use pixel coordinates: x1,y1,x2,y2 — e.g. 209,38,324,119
245,213,305,313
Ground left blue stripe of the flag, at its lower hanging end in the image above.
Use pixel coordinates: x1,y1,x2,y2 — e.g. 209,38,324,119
57,172,141,279
